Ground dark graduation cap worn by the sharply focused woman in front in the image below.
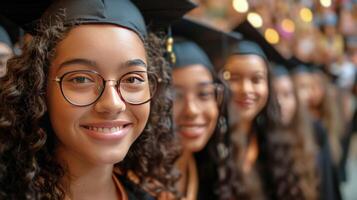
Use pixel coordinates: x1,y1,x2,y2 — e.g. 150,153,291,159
0,0,196,38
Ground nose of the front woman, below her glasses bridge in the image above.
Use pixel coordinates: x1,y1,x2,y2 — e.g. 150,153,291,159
95,80,126,115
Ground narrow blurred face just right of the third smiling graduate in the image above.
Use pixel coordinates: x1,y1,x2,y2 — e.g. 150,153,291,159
273,76,297,125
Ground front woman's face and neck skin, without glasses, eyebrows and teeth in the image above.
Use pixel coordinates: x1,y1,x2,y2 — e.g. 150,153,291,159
47,25,150,198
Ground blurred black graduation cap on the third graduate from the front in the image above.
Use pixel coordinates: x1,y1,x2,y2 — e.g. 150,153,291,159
232,20,292,68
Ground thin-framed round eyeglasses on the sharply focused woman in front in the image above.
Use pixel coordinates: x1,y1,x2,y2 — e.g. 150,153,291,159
54,70,161,107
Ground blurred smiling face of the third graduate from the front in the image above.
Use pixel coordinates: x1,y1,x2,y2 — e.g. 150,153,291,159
225,55,269,121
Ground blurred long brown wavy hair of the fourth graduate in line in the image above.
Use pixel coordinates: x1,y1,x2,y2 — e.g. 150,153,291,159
270,74,319,200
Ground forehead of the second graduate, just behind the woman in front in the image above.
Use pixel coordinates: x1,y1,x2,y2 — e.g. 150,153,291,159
172,64,213,86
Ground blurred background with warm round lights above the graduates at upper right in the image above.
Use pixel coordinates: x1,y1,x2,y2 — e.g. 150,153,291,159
189,0,357,200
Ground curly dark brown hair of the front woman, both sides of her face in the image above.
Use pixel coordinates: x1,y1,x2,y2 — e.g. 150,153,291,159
0,12,178,199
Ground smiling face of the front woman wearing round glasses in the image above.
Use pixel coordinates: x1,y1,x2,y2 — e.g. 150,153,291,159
47,25,150,165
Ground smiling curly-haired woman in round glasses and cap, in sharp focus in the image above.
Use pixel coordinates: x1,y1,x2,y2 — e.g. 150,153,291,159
0,0,195,199
